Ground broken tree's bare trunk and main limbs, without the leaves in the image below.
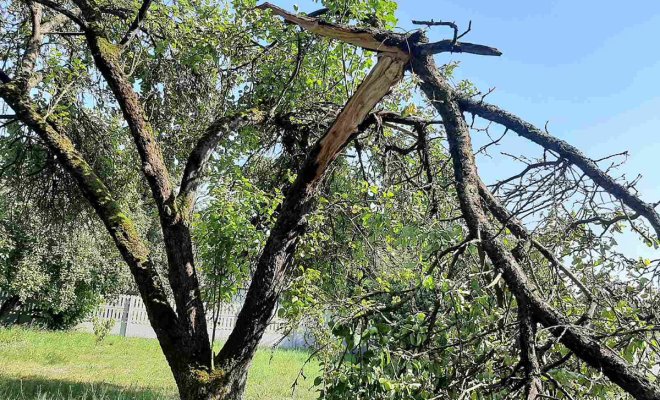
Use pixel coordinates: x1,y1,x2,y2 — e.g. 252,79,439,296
0,0,660,400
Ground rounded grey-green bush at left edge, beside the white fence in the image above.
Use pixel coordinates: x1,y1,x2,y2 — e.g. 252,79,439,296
0,195,128,329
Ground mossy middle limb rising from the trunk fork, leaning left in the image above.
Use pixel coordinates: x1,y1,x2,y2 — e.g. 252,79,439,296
85,21,213,362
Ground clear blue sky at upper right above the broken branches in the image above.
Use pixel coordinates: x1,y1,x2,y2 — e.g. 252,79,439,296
280,0,660,255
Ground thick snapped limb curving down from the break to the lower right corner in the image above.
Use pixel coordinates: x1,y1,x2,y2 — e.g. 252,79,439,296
412,50,660,400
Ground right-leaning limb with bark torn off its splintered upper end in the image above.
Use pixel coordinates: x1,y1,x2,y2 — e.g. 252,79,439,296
216,54,407,378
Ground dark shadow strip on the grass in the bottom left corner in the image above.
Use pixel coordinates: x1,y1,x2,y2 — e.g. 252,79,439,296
0,374,175,400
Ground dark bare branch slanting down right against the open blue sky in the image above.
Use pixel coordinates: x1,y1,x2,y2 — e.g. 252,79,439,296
457,98,660,237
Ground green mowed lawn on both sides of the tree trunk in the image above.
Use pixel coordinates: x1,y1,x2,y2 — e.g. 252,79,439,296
0,328,318,400
